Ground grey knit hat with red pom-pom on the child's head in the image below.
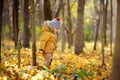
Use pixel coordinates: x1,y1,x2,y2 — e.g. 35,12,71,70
44,18,61,28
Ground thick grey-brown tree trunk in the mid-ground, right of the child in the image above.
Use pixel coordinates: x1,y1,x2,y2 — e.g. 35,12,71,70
75,0,85,54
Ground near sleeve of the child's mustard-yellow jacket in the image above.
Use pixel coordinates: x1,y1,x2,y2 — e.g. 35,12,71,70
40,33,50,51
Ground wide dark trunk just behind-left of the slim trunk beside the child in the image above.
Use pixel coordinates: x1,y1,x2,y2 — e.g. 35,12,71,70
23,0,30,48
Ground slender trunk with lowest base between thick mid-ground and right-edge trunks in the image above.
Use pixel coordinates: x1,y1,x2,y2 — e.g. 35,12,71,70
100,0,105,66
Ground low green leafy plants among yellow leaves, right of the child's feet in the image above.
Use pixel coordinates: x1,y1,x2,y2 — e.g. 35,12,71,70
44,64,93,79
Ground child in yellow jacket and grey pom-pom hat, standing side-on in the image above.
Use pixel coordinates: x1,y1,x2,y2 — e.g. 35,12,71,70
39,18,61,68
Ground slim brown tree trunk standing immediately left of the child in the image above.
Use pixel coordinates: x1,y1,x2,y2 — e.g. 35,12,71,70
30,0,36,66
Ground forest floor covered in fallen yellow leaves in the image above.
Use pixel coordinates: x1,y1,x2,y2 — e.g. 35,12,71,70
0,43,112,80
